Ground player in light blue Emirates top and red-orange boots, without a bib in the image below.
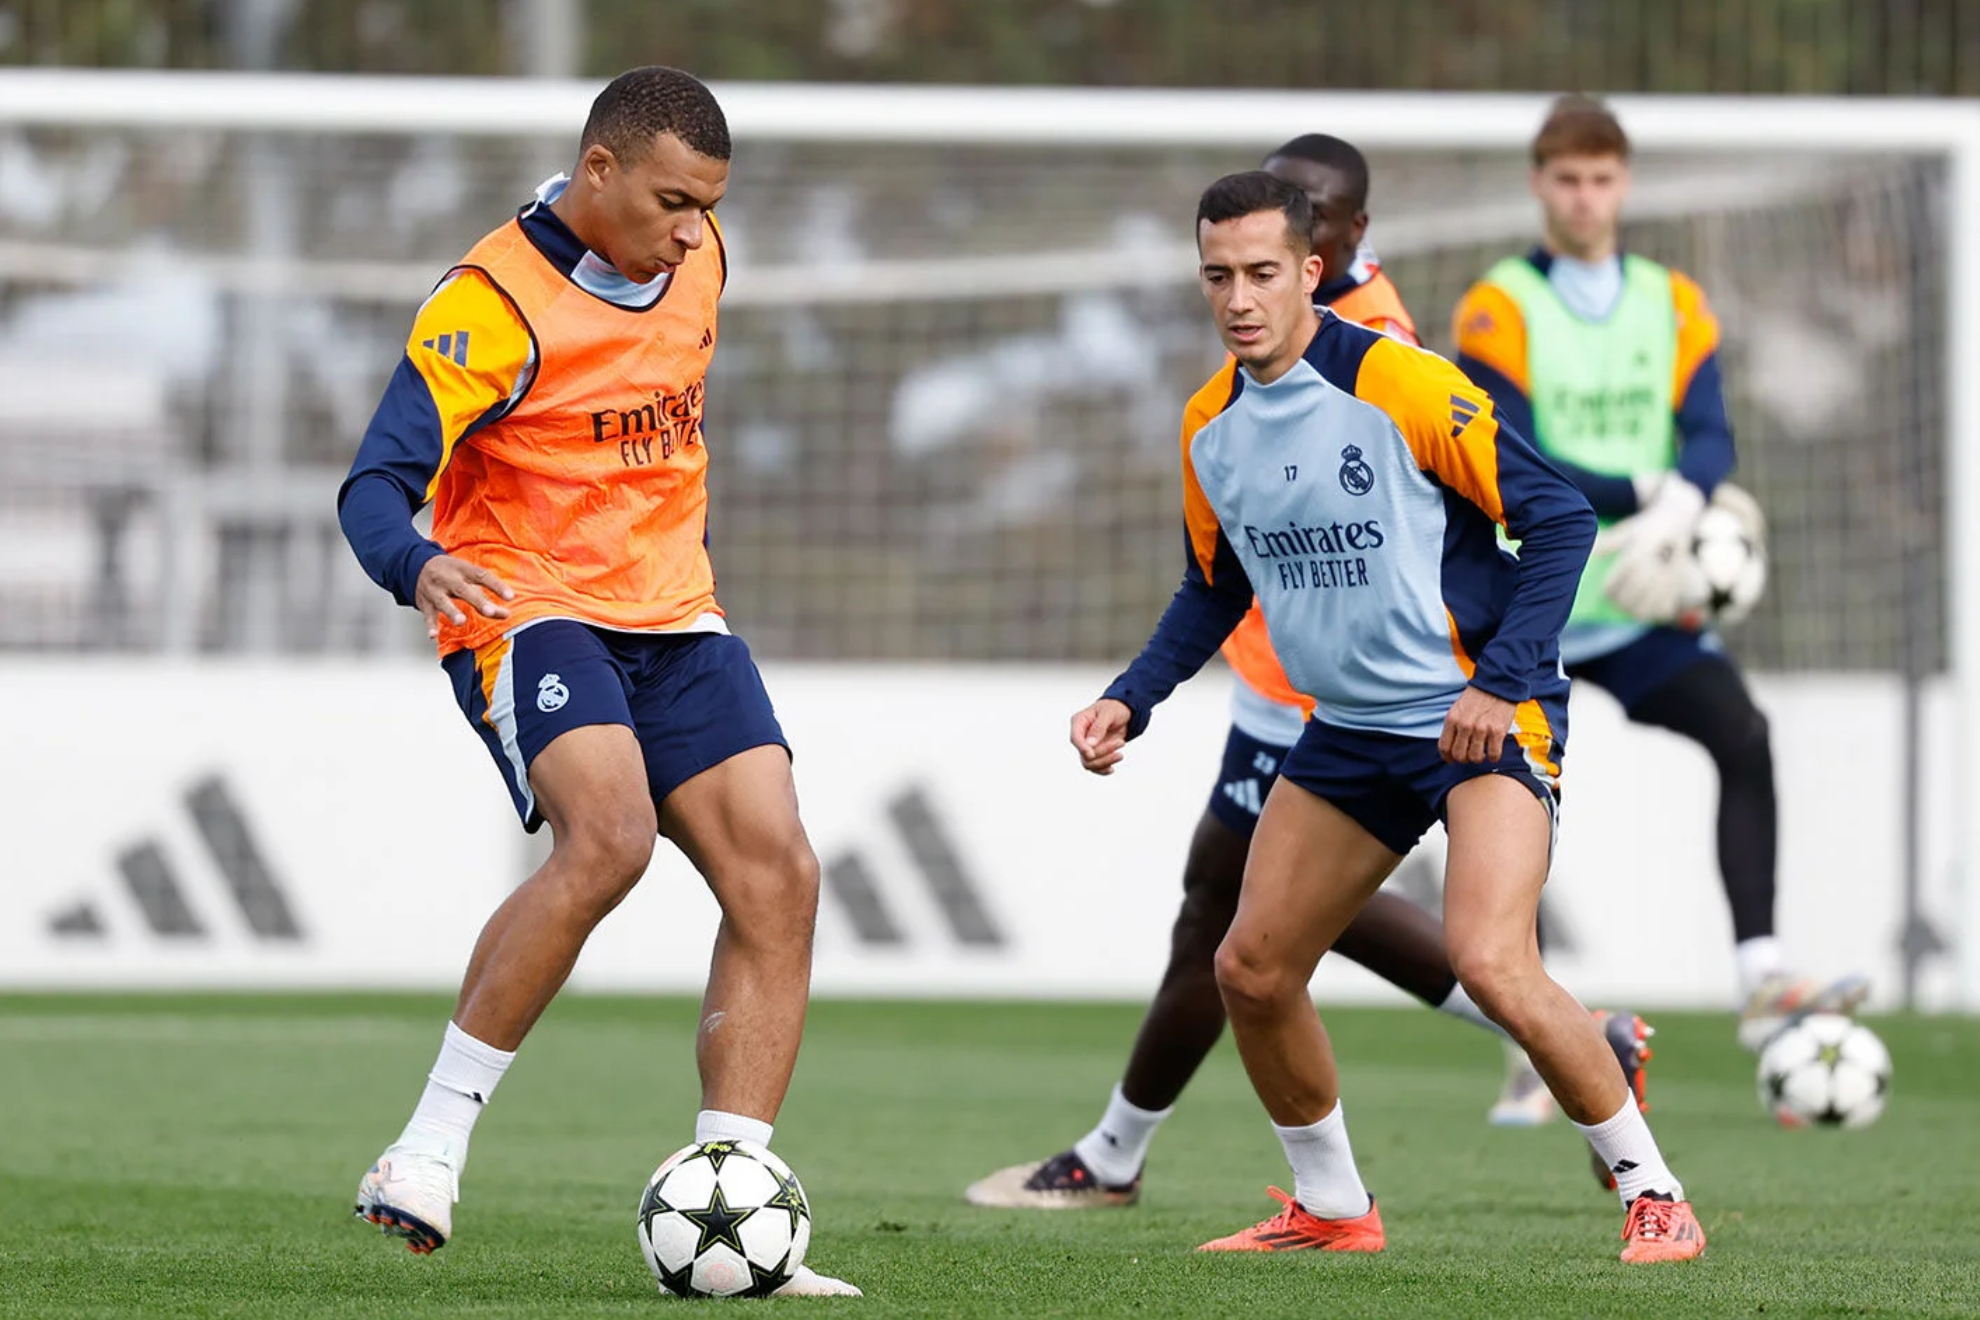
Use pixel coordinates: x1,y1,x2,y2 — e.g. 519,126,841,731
1071,170,1705,1263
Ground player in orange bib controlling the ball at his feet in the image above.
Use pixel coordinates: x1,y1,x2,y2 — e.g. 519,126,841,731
339,67,857,1294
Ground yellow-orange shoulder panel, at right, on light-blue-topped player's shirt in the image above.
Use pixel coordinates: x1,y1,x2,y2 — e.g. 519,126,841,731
1354,338,1505,522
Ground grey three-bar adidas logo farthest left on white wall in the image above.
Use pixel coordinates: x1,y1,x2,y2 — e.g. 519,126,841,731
48,776,305,944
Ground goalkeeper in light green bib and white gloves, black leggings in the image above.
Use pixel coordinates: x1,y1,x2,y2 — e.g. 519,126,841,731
1455,97,1867,1049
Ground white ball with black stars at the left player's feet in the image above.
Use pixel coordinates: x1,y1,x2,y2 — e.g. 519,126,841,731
640,1142,812,1296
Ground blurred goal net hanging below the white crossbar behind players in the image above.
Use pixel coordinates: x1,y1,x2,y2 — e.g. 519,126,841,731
0,77,1952,673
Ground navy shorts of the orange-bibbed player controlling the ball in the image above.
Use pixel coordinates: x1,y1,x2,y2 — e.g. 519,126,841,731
442,619,790,833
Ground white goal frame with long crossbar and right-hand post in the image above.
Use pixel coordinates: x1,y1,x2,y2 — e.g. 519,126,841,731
0,69,1980,1009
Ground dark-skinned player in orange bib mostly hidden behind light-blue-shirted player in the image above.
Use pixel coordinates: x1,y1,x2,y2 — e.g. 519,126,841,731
964,133,1649,1209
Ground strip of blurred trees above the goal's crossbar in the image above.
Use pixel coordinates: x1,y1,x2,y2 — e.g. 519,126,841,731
0,0,1980,95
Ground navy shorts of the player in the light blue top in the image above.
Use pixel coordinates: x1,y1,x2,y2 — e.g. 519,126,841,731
1281,703,1568,855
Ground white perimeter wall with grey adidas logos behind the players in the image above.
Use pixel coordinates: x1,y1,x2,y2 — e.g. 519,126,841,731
0,659,1956,1007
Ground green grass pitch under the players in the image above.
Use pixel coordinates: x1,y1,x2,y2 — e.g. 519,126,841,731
0,995,1980,1318
